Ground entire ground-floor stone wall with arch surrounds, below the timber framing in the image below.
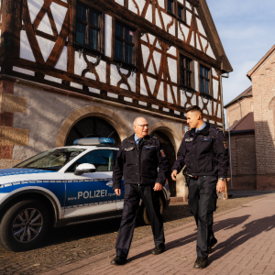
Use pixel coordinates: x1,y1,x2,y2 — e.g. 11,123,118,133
0,83,188,199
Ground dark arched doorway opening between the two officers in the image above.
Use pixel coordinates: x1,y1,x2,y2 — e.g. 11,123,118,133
152,131,177,197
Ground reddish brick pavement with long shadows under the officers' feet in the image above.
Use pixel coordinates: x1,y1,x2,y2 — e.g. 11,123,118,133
43,194,275,275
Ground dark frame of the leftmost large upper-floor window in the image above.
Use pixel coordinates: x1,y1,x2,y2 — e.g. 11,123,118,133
73,0,104,54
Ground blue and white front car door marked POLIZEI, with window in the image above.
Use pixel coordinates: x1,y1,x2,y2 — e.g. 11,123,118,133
64,149,117,218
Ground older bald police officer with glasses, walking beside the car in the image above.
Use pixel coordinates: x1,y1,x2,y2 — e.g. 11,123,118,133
111,117,169,265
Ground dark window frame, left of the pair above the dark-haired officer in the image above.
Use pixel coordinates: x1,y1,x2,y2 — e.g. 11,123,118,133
179,53,195,91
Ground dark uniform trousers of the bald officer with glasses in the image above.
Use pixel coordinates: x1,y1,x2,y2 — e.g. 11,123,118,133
116,184,165,258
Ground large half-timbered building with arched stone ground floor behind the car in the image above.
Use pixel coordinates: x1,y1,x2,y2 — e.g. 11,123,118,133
0,0,232,197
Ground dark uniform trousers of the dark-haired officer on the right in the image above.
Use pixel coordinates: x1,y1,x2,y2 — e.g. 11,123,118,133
188,176,218,258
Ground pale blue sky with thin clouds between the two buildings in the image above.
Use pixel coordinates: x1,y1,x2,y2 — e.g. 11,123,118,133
206,0,275,104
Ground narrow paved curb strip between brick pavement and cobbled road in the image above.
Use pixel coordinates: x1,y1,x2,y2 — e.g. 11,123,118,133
41,194,268,275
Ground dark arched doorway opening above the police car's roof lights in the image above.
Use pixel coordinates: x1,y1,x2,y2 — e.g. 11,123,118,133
66,116,121,146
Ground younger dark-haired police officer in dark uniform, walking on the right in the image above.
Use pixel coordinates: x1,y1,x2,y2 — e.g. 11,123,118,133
171,106,229,268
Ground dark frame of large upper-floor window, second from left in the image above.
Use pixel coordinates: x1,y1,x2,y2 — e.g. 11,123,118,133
112,18,137,68
